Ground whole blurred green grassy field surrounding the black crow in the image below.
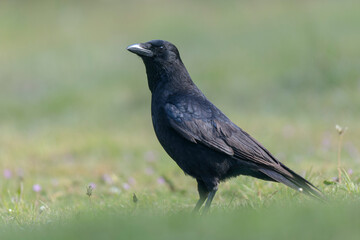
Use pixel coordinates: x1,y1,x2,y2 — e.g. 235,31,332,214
0,0,360,239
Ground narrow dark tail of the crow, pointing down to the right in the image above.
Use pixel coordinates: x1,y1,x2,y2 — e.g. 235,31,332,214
260,164,325,200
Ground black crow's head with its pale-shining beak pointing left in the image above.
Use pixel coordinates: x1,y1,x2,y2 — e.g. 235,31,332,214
126,40,181,65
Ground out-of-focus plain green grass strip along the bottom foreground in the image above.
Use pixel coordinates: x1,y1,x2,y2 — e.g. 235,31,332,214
2,204,360,240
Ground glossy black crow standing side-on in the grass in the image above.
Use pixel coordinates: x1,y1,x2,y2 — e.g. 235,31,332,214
127,40,322,211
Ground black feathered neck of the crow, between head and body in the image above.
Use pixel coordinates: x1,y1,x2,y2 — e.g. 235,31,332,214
145,61,194,93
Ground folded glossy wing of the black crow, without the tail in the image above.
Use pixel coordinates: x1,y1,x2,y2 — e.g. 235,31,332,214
165,101,279,165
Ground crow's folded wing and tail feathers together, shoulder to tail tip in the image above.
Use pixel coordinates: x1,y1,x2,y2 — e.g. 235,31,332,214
165,100,322,197
